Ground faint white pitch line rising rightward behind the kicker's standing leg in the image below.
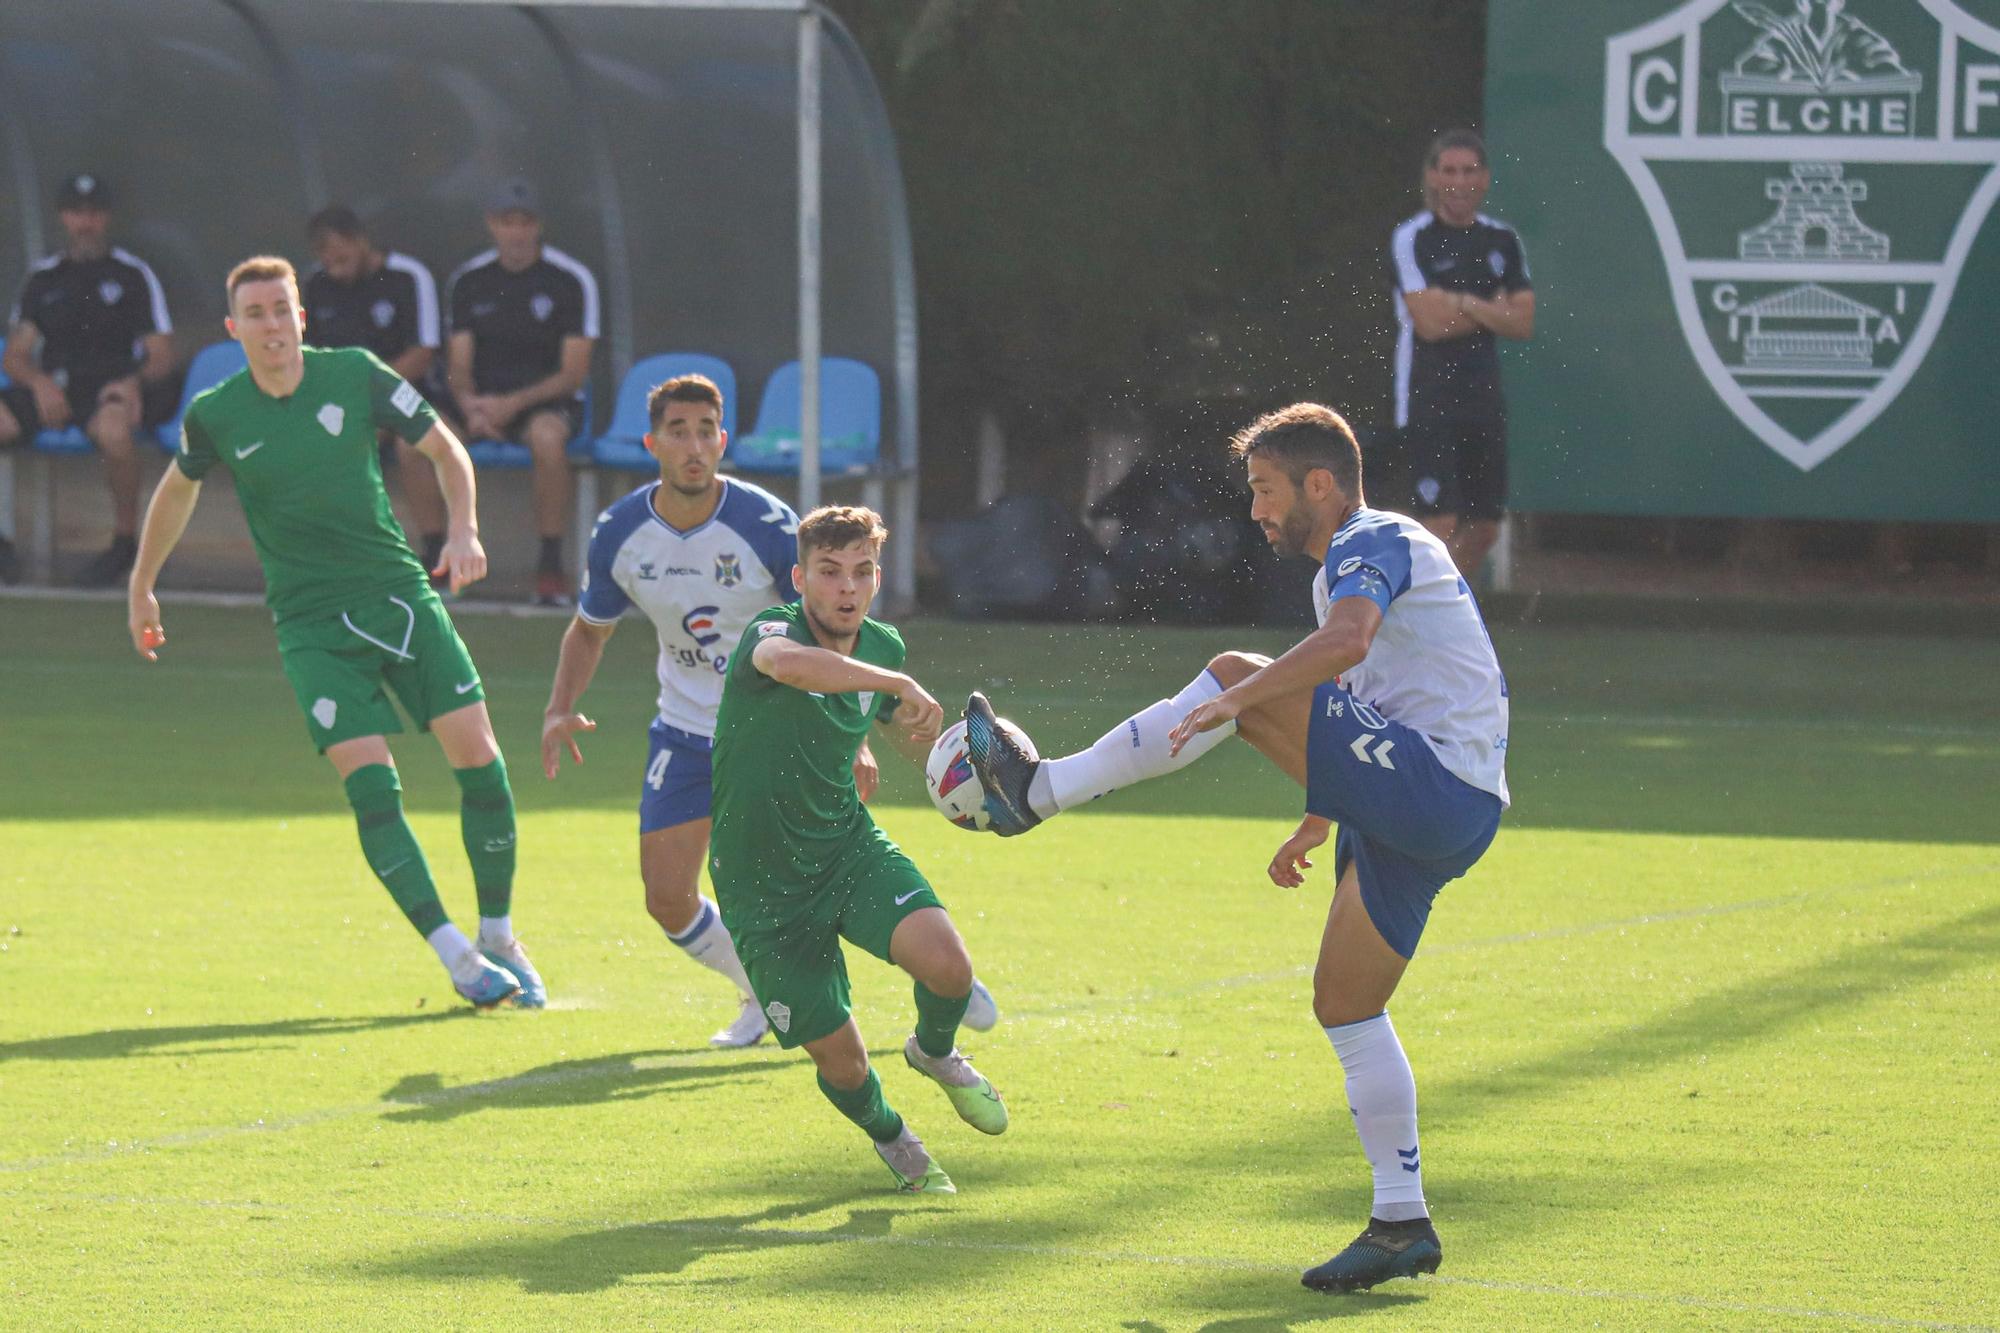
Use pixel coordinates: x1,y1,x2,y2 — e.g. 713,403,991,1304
0,865,2000,1175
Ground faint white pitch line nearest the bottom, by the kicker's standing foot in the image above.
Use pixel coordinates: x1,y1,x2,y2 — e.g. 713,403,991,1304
0,1191,1994,1333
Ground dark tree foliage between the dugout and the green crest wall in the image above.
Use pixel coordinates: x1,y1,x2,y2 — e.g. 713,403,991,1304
830,0,1504,514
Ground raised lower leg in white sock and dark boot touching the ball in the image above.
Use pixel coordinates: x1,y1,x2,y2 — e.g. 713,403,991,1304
966,654,1232,837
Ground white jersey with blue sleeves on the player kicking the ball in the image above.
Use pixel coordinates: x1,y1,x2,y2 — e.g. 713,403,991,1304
1312,508,1510,805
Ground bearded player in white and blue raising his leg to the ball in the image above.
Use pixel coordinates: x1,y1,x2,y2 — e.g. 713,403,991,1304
966,402,1508,1291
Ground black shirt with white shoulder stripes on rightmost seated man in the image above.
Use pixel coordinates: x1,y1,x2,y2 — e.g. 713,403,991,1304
450,246,598,394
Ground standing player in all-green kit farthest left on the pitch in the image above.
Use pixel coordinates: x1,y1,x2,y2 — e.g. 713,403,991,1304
128,256,548,1009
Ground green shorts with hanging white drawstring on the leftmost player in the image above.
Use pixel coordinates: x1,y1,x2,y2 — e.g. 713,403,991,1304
278,588,486,753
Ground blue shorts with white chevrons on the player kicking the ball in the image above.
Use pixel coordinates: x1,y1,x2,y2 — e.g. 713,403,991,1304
1306,685,1500,959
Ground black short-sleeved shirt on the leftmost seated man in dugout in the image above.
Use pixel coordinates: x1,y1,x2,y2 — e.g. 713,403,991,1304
8,248,174,382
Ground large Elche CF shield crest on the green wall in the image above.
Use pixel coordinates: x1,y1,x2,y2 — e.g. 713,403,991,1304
1604,0,2000,470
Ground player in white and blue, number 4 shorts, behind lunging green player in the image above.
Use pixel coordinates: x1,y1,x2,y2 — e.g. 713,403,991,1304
542,374,998,1047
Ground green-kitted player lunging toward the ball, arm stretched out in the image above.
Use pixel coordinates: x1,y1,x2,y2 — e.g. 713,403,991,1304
708,506,1006,1193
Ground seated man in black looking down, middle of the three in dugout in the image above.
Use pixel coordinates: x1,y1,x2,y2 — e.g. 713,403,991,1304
300,204,444,568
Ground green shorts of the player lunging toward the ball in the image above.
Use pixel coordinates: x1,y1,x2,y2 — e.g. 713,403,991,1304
716,827,944,1051
